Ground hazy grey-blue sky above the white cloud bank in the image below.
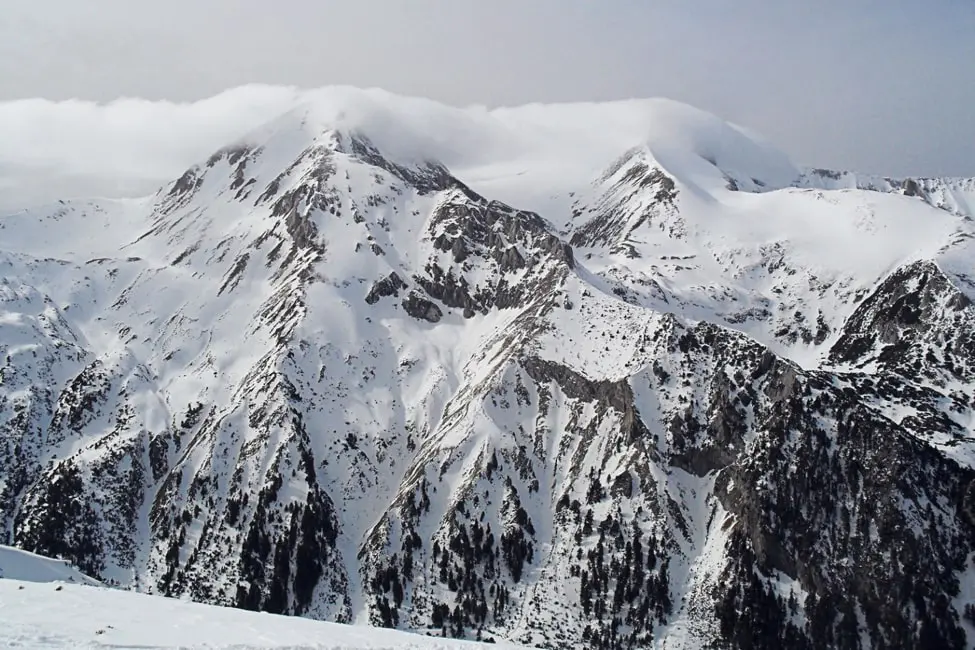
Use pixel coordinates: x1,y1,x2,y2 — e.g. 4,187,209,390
0,0,975,176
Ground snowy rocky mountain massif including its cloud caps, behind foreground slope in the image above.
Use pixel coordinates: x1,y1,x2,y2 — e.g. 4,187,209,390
0,89,975,648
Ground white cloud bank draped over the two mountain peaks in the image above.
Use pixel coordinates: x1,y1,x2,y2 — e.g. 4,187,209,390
0,85,798,210
